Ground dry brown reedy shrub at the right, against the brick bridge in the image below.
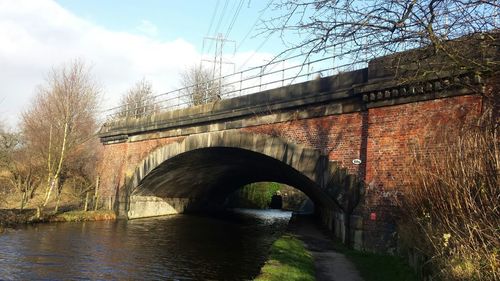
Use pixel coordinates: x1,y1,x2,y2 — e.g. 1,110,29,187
400,110,500,280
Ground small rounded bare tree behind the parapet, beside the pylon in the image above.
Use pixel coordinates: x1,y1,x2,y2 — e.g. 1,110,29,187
181,66,224,105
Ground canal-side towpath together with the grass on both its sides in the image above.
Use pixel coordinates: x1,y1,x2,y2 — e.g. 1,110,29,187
255,216,417,281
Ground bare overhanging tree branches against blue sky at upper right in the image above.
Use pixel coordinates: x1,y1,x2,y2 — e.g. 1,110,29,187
261,0,499,77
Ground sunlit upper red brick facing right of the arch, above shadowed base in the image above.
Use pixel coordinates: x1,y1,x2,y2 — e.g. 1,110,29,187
241,96,481,190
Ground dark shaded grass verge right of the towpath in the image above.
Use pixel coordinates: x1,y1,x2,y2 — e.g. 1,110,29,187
334,238,418,281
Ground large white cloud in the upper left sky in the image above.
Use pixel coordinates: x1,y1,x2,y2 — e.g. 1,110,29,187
0,0,199,125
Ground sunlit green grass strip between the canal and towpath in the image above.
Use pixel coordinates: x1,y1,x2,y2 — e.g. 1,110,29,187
255,234,315,281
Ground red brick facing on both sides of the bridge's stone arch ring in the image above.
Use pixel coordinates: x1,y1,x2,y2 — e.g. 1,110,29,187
98,93,481,250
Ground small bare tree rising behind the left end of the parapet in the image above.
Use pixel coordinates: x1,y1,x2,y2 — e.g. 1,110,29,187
118,78,158,118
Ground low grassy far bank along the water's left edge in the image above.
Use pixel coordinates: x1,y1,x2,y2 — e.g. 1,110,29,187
0,209,116,230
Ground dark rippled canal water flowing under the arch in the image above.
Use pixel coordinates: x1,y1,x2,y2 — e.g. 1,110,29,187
0,210,291,280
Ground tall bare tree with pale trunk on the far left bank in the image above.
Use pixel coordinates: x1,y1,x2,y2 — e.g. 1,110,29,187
22,61,99,209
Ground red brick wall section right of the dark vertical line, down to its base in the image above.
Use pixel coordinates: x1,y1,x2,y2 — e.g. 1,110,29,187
357,96,481,249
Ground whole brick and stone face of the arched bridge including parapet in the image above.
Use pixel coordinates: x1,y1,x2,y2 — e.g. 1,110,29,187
99,36,492,251
